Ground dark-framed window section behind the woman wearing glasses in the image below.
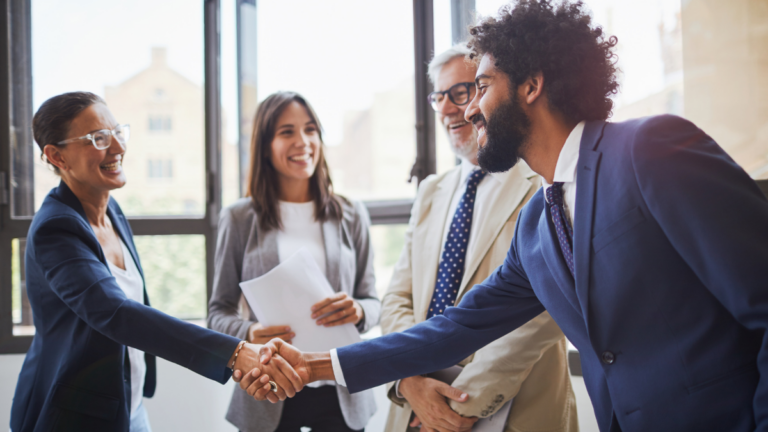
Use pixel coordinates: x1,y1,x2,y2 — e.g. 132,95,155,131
0,0,221,352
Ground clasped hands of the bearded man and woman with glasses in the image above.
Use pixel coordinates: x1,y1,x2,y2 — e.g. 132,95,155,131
232,338,335,403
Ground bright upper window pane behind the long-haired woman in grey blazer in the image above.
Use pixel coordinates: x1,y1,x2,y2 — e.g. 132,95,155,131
257,0,416,199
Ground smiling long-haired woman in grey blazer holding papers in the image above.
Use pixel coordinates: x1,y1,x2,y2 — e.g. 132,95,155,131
208,92,381,432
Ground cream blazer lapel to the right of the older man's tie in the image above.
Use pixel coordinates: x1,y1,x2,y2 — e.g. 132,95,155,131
457,163,533,298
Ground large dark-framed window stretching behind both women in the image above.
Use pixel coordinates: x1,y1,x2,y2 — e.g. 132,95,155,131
0,0,434,352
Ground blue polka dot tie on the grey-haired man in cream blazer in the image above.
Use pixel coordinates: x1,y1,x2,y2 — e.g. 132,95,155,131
427,170,485,319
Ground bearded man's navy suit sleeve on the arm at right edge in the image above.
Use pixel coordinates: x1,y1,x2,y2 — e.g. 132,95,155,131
632,116,768,430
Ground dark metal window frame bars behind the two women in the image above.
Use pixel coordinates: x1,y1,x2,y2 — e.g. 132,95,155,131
0,0,456,354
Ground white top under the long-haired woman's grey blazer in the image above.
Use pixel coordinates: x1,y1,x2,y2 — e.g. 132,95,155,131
277,201,334,388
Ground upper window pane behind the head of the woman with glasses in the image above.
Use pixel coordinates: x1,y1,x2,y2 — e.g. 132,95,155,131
27,0,206,215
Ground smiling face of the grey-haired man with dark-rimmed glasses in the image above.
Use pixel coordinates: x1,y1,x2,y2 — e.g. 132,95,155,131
435,57,477,163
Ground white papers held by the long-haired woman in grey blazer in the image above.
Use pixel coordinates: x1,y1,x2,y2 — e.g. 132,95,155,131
240,249,361,352
